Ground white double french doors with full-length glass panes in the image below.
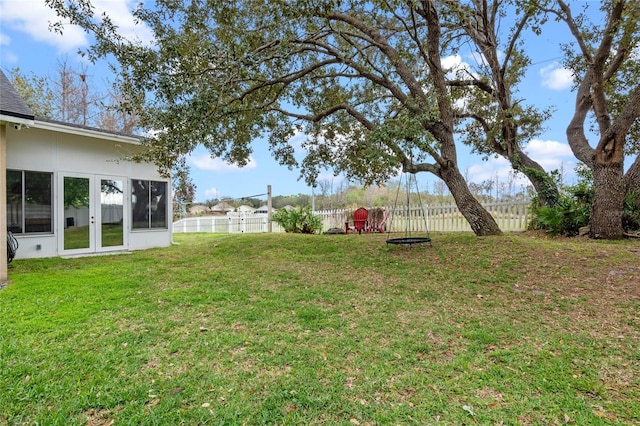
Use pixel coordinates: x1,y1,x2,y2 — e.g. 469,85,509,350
58,173,128,254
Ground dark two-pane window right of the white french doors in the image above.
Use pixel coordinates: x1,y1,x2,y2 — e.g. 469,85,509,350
131,179,167,229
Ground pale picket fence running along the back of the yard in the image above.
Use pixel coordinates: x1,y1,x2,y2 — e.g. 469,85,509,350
173,201,530,234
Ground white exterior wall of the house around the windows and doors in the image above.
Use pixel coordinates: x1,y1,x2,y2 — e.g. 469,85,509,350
2,121,172,258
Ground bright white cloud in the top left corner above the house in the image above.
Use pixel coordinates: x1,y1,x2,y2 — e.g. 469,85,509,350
0,0,153,53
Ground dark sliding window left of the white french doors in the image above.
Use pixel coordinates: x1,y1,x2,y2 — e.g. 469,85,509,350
7,170,53,234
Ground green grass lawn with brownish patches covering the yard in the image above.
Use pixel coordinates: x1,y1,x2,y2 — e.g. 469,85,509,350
0,234,640,426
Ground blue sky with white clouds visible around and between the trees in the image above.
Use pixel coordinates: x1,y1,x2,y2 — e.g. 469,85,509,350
0,0,592,202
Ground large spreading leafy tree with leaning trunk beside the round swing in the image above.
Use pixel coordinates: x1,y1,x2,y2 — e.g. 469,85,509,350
48,0,520,235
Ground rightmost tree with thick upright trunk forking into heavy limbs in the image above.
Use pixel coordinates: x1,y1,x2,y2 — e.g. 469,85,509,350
546,0,640,239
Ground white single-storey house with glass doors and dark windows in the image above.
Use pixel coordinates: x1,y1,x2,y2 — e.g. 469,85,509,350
0,71,172,281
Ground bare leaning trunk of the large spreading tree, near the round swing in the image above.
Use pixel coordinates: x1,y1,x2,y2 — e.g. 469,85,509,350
440,166,502,237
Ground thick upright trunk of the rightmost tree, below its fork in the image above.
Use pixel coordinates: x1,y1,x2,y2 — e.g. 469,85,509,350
589,162,625,240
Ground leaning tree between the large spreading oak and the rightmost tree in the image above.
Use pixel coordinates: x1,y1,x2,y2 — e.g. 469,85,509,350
441,0,559,206
